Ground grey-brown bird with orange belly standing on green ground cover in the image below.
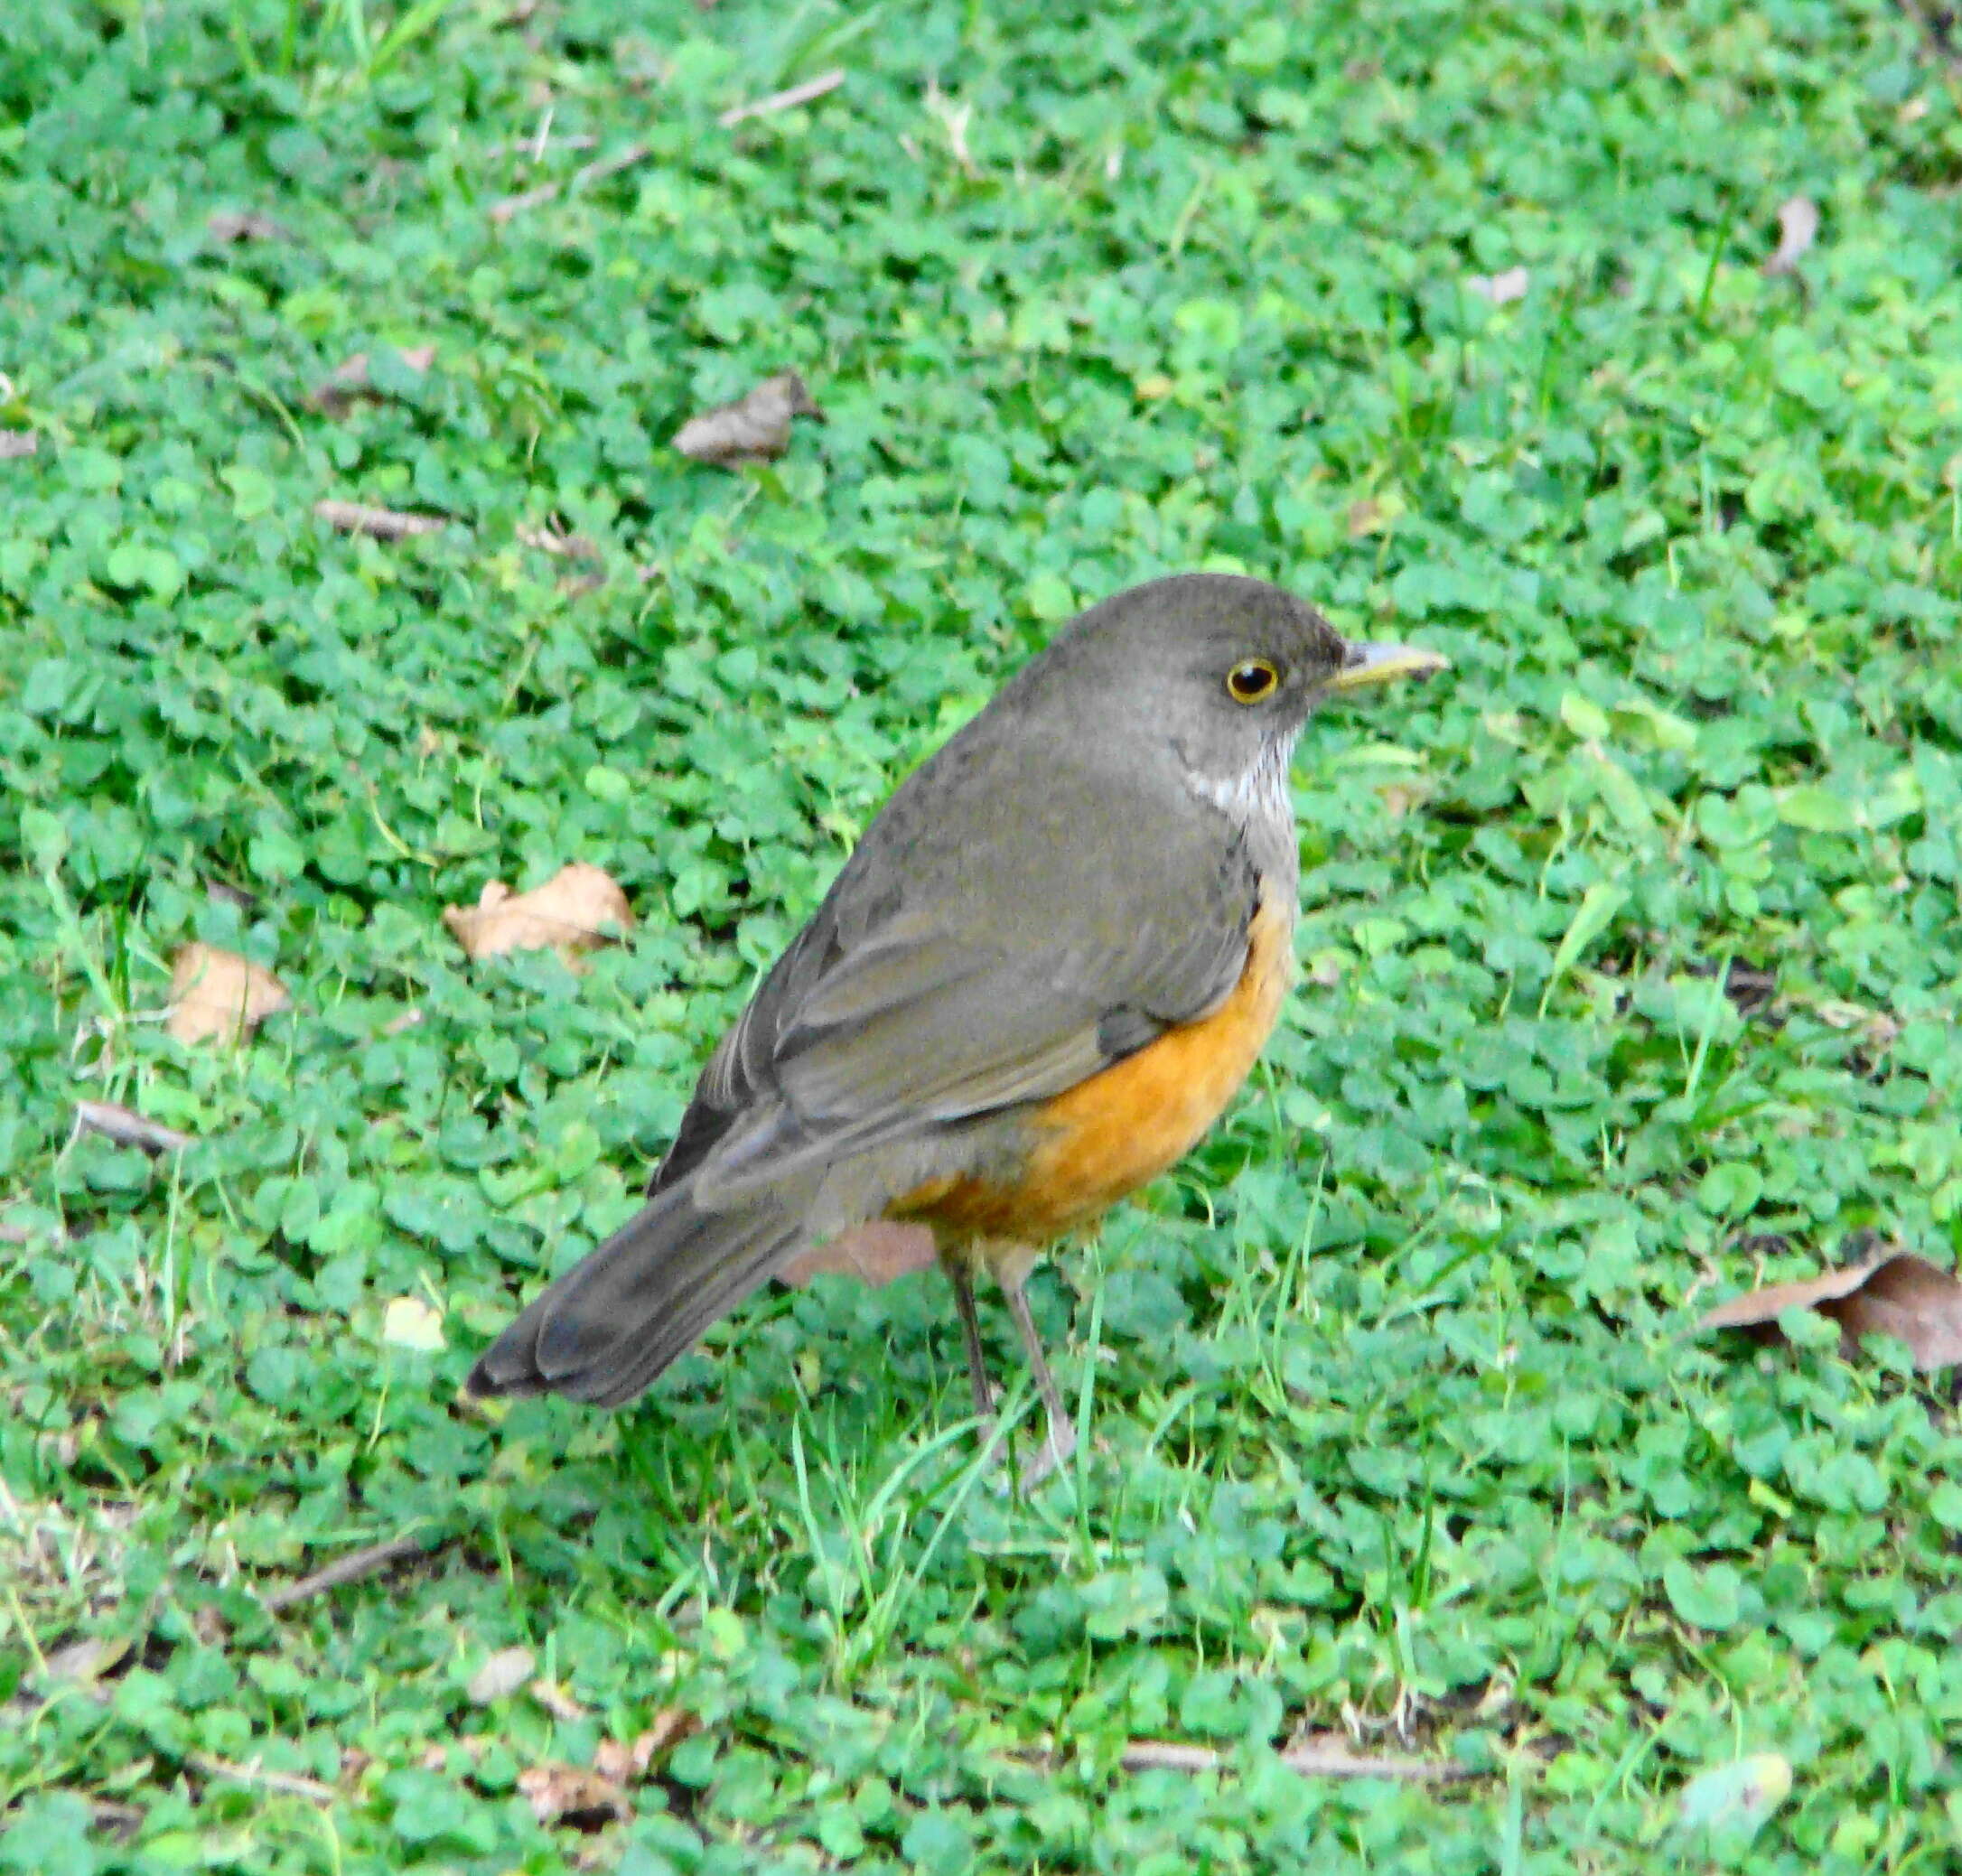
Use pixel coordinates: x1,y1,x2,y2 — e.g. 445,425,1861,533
465,573,1446,1486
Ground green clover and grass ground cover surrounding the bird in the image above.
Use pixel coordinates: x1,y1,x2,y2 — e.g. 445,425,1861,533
0,0,1962,1876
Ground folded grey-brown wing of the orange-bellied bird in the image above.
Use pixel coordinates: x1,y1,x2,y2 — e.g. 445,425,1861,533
649,743,1257,1203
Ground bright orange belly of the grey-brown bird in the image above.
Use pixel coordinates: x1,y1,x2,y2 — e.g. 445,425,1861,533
887,902,1293,1250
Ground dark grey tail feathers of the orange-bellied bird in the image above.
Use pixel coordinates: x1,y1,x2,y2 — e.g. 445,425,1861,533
463,1185,802,1407
